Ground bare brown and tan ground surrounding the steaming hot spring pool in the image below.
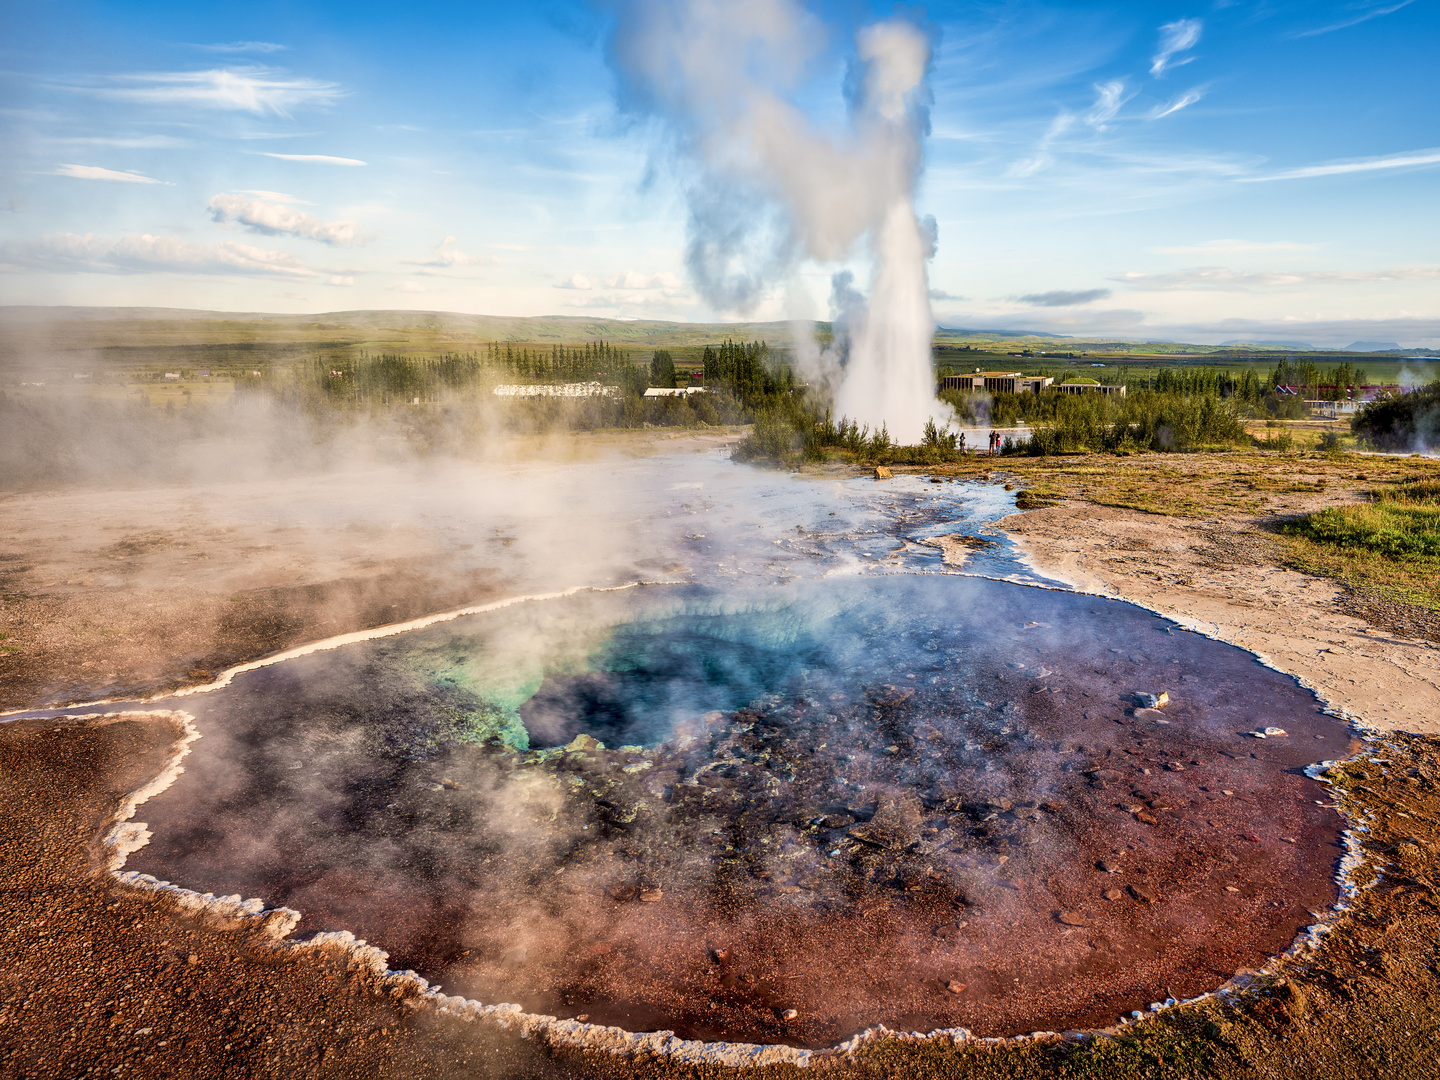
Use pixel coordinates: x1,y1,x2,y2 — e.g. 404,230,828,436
0,455,1440,1080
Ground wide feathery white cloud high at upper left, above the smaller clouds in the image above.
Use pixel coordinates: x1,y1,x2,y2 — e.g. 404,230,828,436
96,66,344,115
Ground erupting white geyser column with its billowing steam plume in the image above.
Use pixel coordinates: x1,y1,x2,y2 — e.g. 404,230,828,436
612,0,943,439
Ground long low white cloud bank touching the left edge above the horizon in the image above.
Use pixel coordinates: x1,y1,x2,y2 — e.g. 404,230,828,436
0,232,315,278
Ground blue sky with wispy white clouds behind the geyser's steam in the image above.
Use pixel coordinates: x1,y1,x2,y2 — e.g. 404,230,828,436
0,0,1440,347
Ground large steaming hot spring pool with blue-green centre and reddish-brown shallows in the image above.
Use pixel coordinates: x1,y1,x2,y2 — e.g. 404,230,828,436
128,573,1348,1047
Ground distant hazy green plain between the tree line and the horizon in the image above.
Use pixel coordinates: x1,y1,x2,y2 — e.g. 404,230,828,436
0,307,1440,403
